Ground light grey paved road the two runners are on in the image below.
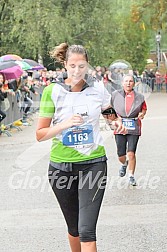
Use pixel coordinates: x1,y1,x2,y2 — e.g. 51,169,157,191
0,94,167,252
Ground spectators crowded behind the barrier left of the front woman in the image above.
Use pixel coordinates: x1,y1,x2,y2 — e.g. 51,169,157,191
0,70,50,132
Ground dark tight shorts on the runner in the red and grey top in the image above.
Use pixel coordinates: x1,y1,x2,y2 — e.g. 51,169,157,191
115,134,139,157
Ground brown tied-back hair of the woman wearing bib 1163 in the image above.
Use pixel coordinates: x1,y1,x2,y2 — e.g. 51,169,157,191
50,43,88,65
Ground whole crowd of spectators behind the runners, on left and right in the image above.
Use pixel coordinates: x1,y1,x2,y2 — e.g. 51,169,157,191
0,60,167,134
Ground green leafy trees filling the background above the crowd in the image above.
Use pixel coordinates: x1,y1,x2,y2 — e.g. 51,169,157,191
0,0,167,71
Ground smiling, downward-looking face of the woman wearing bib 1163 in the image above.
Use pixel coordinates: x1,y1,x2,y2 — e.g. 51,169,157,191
64,53,88,85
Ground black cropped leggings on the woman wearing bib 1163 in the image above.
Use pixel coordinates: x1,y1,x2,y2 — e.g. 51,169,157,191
49,161,107,242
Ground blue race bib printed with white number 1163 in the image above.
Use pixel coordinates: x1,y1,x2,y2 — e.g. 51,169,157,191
62,125,93,148
